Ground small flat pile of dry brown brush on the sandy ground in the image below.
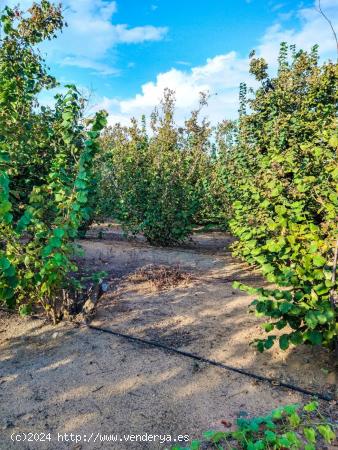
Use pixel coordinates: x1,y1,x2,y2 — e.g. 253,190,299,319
128,264,193,291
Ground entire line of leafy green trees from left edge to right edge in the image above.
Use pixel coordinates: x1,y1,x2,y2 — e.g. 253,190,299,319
0,0,338,350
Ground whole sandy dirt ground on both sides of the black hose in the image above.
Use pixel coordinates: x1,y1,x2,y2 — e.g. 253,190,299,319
0,226,337,450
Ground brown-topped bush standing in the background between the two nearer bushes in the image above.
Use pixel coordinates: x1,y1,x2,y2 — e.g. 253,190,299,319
98,90,215,246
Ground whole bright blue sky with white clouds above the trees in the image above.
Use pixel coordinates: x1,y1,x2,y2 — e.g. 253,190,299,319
0,0,338,123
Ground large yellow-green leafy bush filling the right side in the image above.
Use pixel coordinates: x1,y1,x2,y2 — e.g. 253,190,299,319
226,44,338,351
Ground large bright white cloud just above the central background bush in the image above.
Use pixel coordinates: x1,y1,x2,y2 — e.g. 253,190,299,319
94,52,251,124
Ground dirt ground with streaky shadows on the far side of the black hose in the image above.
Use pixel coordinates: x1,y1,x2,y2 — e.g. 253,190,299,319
85,232,337,394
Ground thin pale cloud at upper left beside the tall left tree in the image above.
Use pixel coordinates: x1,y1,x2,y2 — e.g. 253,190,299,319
4,0,168,75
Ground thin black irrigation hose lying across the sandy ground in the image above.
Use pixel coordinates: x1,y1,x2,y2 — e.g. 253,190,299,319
87,324,334,402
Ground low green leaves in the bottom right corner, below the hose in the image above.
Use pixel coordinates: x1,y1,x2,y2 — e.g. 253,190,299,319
172,401,336,450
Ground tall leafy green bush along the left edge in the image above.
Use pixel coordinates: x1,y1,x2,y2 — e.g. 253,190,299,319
0,1,106,321
